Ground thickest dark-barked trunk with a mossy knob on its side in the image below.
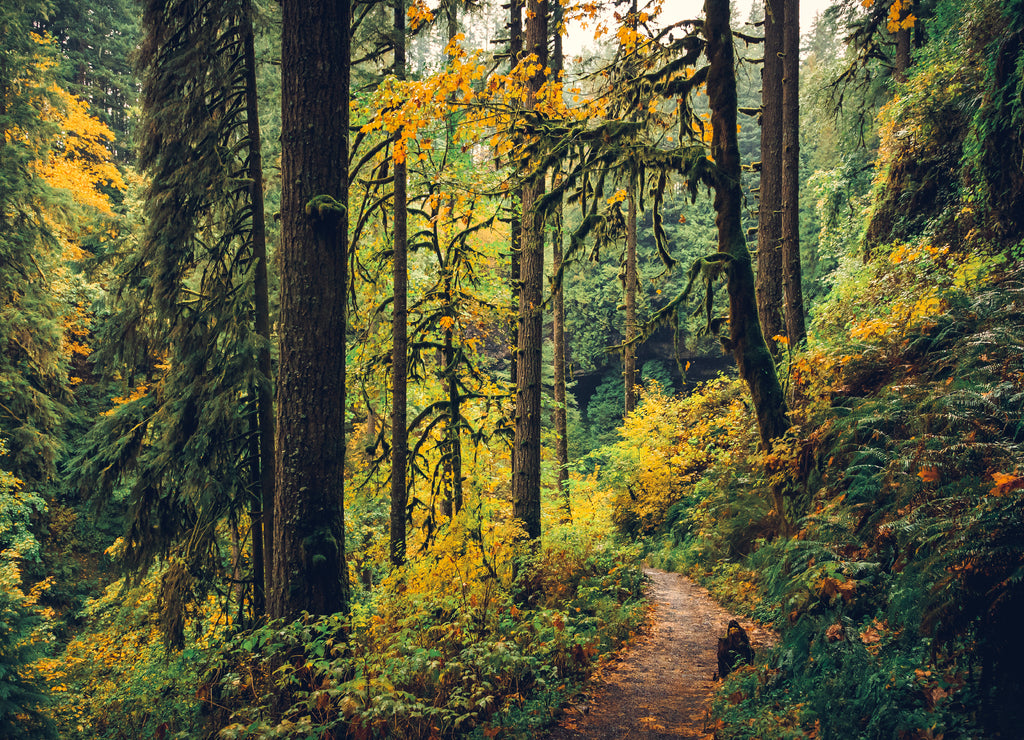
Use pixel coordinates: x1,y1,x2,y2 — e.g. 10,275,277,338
269,0,351,618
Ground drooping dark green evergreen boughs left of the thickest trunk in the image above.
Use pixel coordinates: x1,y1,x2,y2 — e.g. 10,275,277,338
73,2,269,626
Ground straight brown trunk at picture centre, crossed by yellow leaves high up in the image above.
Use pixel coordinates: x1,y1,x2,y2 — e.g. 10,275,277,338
512,0,548,539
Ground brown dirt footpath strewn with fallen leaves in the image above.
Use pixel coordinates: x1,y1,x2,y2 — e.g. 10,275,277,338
549,568,775,740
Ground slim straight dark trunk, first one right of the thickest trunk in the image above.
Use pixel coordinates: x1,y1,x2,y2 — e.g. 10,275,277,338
389,0,409,567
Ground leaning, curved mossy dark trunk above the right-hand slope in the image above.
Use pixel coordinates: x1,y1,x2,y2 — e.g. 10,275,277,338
705,0,788,449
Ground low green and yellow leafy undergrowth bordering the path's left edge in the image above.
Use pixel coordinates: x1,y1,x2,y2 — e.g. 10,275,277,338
200,536,644,739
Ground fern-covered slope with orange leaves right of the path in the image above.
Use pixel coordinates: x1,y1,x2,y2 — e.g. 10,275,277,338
620,261,1024,738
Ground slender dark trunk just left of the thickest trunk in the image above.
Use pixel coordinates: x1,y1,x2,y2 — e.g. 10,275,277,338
243,2,274,614
